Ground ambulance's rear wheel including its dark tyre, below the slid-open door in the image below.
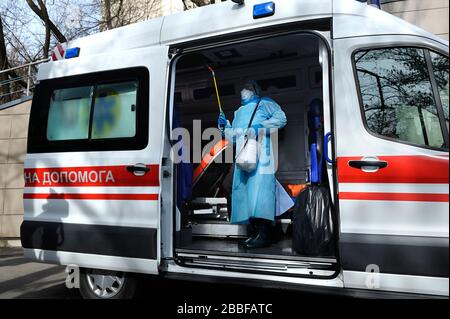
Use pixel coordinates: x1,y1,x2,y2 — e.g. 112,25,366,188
80,269,137,299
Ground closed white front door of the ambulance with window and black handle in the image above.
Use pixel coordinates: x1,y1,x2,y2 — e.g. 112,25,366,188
334,36,449,295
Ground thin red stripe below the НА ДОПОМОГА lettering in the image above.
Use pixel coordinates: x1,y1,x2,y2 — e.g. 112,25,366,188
23,193,159,200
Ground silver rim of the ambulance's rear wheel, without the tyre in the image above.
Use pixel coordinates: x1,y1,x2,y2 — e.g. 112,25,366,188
86,272,125,298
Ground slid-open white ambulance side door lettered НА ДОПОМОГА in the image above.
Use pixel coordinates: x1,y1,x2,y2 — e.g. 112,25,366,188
21,48,167,273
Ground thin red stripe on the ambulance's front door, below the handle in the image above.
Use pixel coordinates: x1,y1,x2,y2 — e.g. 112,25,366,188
339,192,448,202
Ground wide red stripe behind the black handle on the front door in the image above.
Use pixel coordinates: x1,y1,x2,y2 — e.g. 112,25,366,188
337,155,449,184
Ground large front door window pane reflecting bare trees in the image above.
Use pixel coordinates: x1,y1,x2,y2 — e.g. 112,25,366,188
355,48,444,148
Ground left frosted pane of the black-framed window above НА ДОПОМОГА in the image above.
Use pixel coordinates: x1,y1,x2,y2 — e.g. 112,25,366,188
47,86,92,141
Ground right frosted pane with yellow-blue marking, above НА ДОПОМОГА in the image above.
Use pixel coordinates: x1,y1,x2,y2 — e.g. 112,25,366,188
92,81,138,139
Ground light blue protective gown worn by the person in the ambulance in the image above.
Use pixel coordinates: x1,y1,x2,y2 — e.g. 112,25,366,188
224,95,287,224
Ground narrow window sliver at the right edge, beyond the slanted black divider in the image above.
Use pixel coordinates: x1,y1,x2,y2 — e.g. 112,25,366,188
430,52,449,131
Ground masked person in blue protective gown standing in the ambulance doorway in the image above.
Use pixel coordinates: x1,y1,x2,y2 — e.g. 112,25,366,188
218,81,287,248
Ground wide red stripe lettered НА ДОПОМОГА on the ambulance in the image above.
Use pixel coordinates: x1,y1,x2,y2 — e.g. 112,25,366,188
24,165,159,187
